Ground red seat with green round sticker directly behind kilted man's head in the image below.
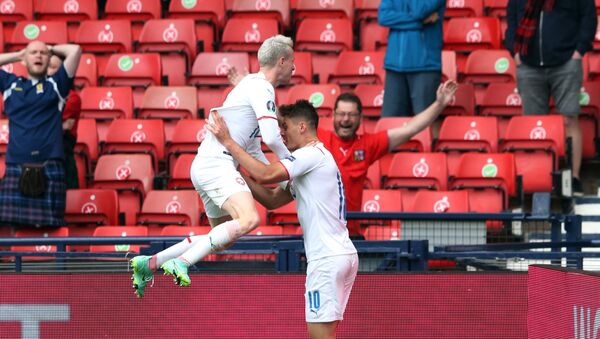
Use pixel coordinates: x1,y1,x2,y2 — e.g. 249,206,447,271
5,21,68,51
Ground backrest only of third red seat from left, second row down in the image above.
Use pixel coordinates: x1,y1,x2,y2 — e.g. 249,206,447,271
137,19,197,61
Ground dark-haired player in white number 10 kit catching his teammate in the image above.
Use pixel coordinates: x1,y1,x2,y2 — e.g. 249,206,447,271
207,100,358,338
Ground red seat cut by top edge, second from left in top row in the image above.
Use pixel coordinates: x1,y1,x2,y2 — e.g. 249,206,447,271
35,0,98,41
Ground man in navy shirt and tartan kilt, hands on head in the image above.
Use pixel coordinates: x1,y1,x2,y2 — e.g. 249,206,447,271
0,41,81,226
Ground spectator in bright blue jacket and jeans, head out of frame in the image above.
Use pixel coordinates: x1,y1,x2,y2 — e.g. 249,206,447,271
378,0,446,117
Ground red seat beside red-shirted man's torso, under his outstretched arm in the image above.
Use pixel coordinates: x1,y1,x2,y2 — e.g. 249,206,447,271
380,152,448,210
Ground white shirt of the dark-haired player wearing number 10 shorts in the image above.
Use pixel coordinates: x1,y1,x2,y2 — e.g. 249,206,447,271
281,142,356,261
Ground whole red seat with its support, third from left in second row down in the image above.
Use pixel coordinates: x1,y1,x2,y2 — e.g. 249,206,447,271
137,19,197,86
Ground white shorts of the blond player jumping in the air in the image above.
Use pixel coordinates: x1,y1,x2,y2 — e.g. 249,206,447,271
190,156,250,219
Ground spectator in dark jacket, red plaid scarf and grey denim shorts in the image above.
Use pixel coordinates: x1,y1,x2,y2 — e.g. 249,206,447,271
505,0,597,195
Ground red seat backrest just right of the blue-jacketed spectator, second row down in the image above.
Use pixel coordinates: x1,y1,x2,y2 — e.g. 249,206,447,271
444,17,502,51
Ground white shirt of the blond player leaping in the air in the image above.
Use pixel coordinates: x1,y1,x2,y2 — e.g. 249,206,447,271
198,73,290,166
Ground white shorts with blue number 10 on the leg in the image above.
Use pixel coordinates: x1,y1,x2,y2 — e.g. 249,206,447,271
304,253,358,323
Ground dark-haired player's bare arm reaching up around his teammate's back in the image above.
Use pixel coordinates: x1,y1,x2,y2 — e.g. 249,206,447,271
206,111,289,184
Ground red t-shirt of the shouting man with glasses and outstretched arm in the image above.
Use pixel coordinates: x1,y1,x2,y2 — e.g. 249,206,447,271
317,129,389,234
